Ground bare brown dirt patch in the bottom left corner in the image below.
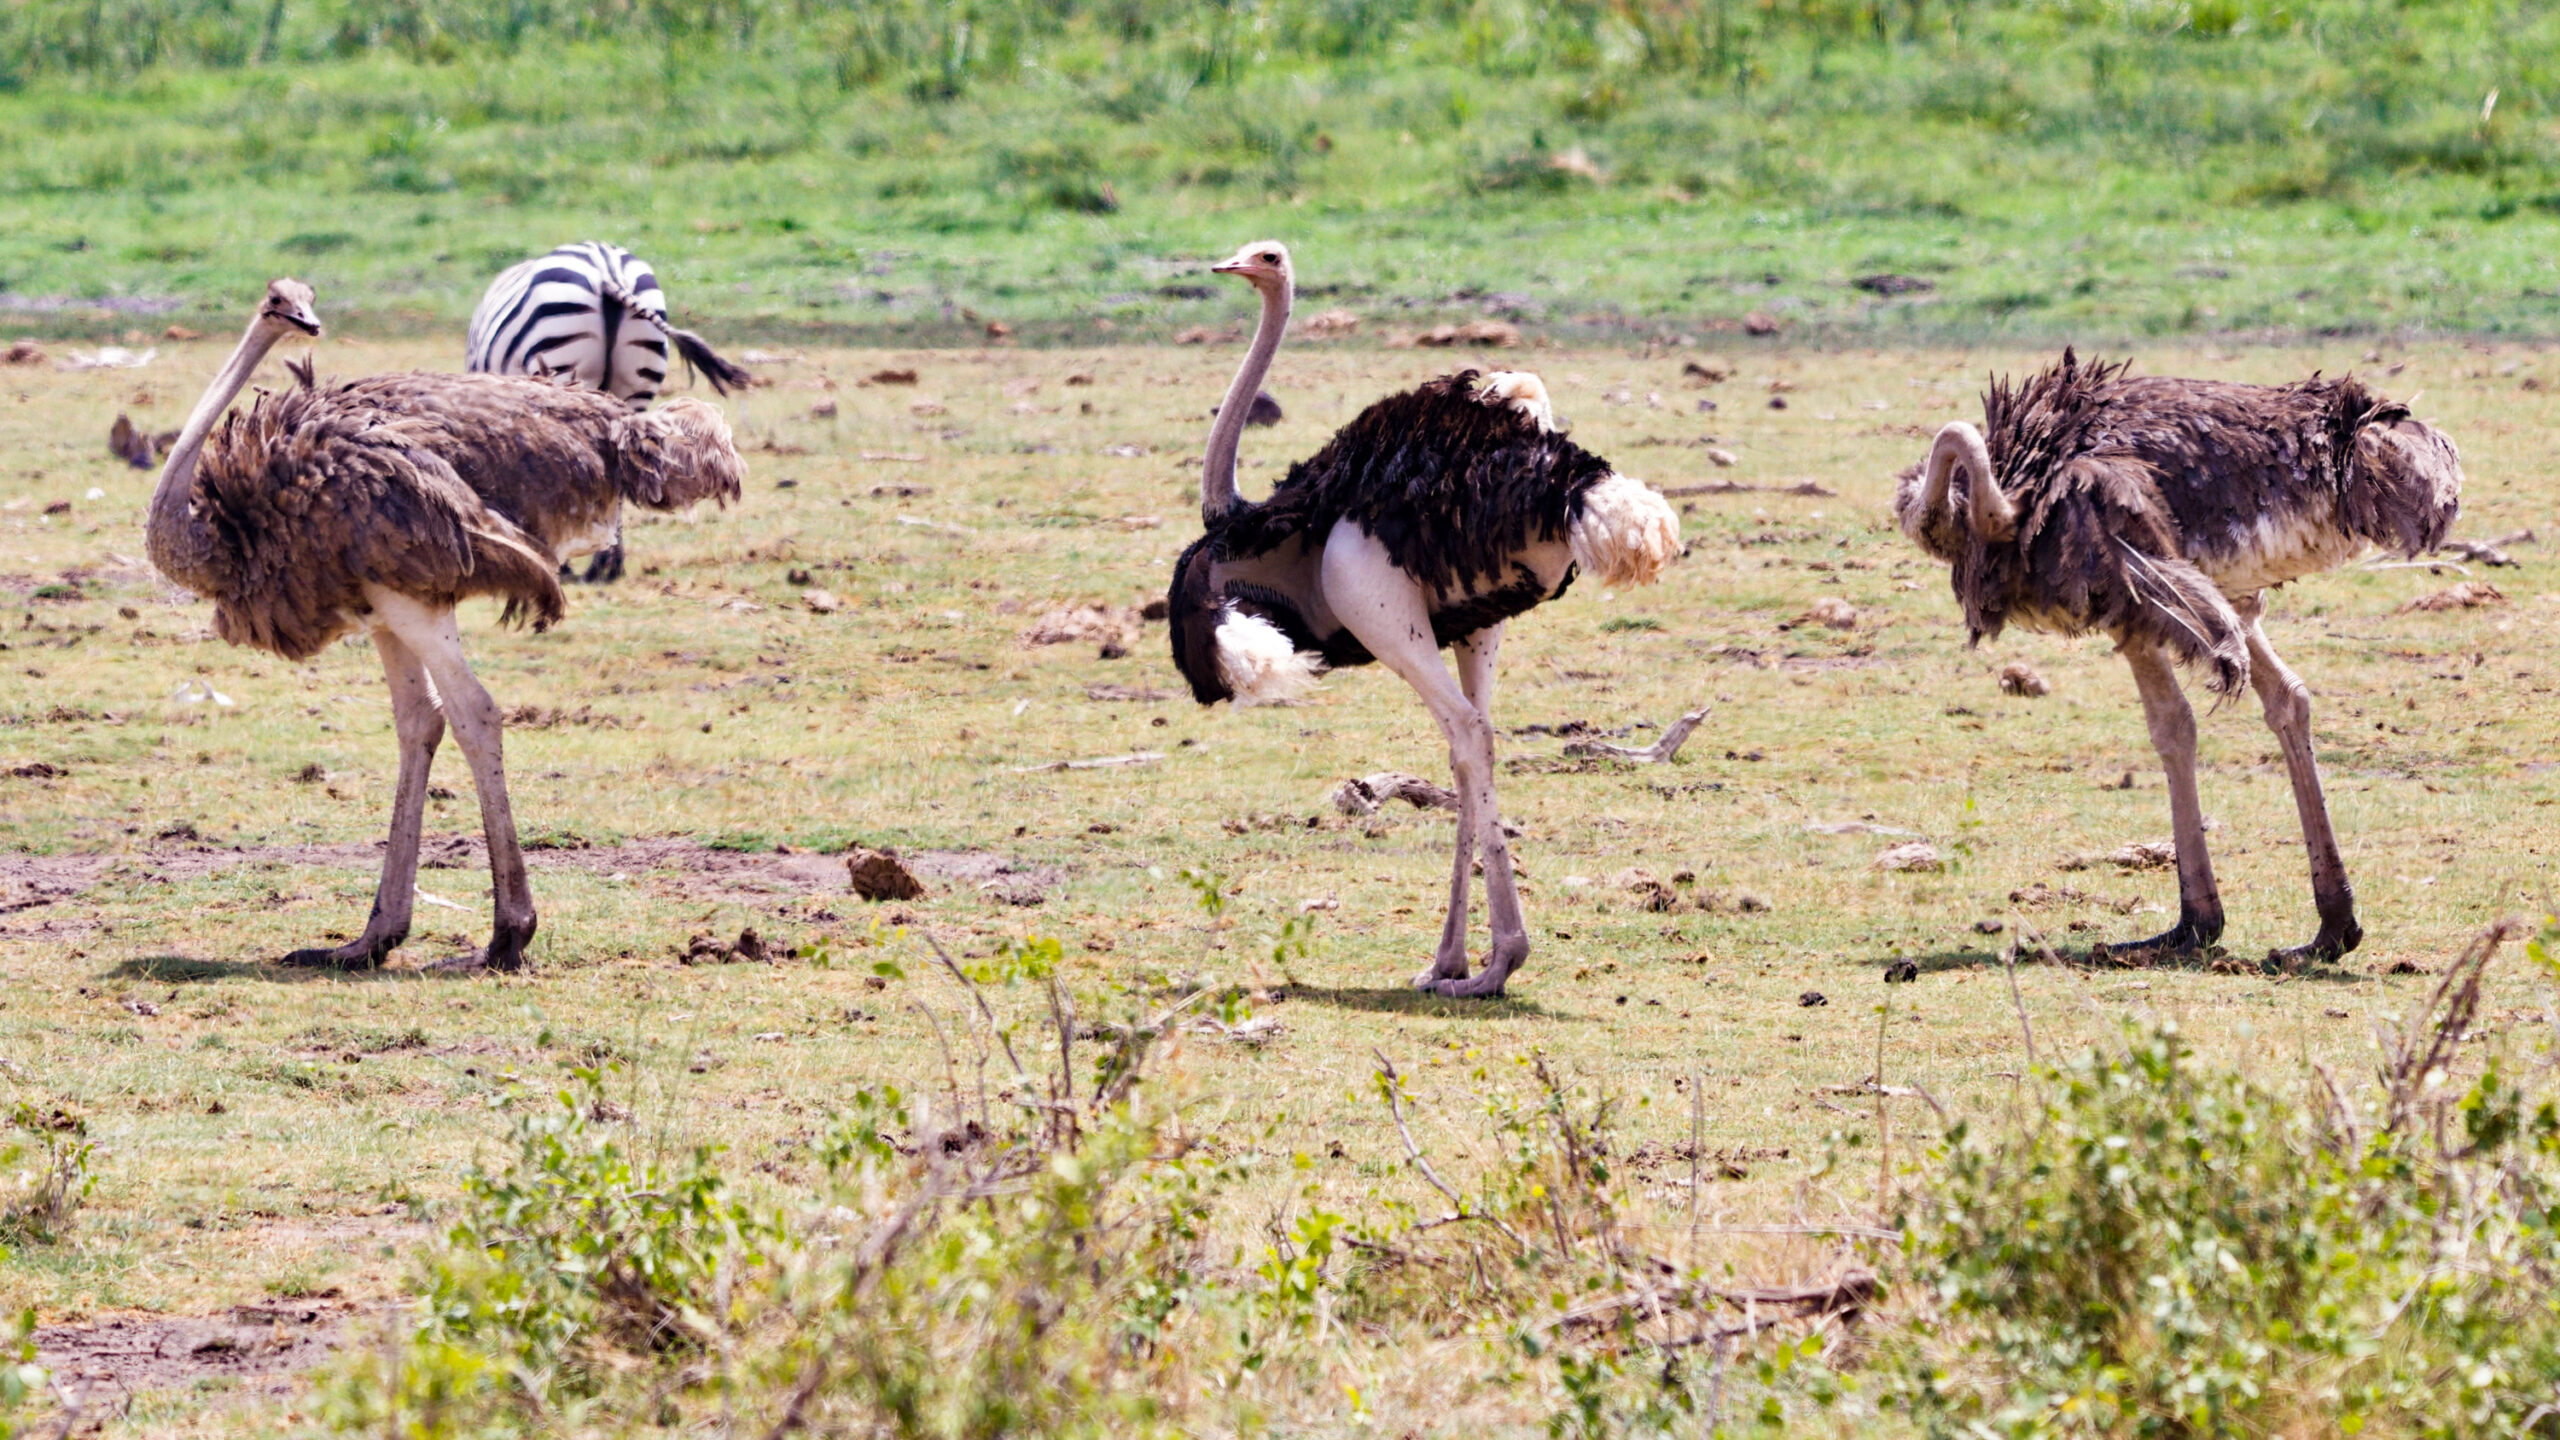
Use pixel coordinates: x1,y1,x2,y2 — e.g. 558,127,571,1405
36,1297,361,1414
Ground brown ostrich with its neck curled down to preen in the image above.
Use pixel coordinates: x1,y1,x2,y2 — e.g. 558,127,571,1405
1894,351,2463,966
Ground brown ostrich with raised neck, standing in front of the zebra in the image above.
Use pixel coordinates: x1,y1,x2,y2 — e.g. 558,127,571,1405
148,279,745,969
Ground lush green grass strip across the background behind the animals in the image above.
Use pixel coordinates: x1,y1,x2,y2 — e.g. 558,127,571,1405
0,0,2560,343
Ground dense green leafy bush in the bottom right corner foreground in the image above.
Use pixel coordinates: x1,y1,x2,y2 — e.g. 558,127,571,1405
1887,930,2560,1435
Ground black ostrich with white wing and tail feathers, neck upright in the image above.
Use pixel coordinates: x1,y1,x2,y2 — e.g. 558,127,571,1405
1167,241,1679,997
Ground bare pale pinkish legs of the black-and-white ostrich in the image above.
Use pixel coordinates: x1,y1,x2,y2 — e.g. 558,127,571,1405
1321,523,1528,997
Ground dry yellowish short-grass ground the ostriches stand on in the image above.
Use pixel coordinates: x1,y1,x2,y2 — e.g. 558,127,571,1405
0,341,2560,1427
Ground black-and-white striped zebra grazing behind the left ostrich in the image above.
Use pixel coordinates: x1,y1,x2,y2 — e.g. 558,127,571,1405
463,241,748,584
